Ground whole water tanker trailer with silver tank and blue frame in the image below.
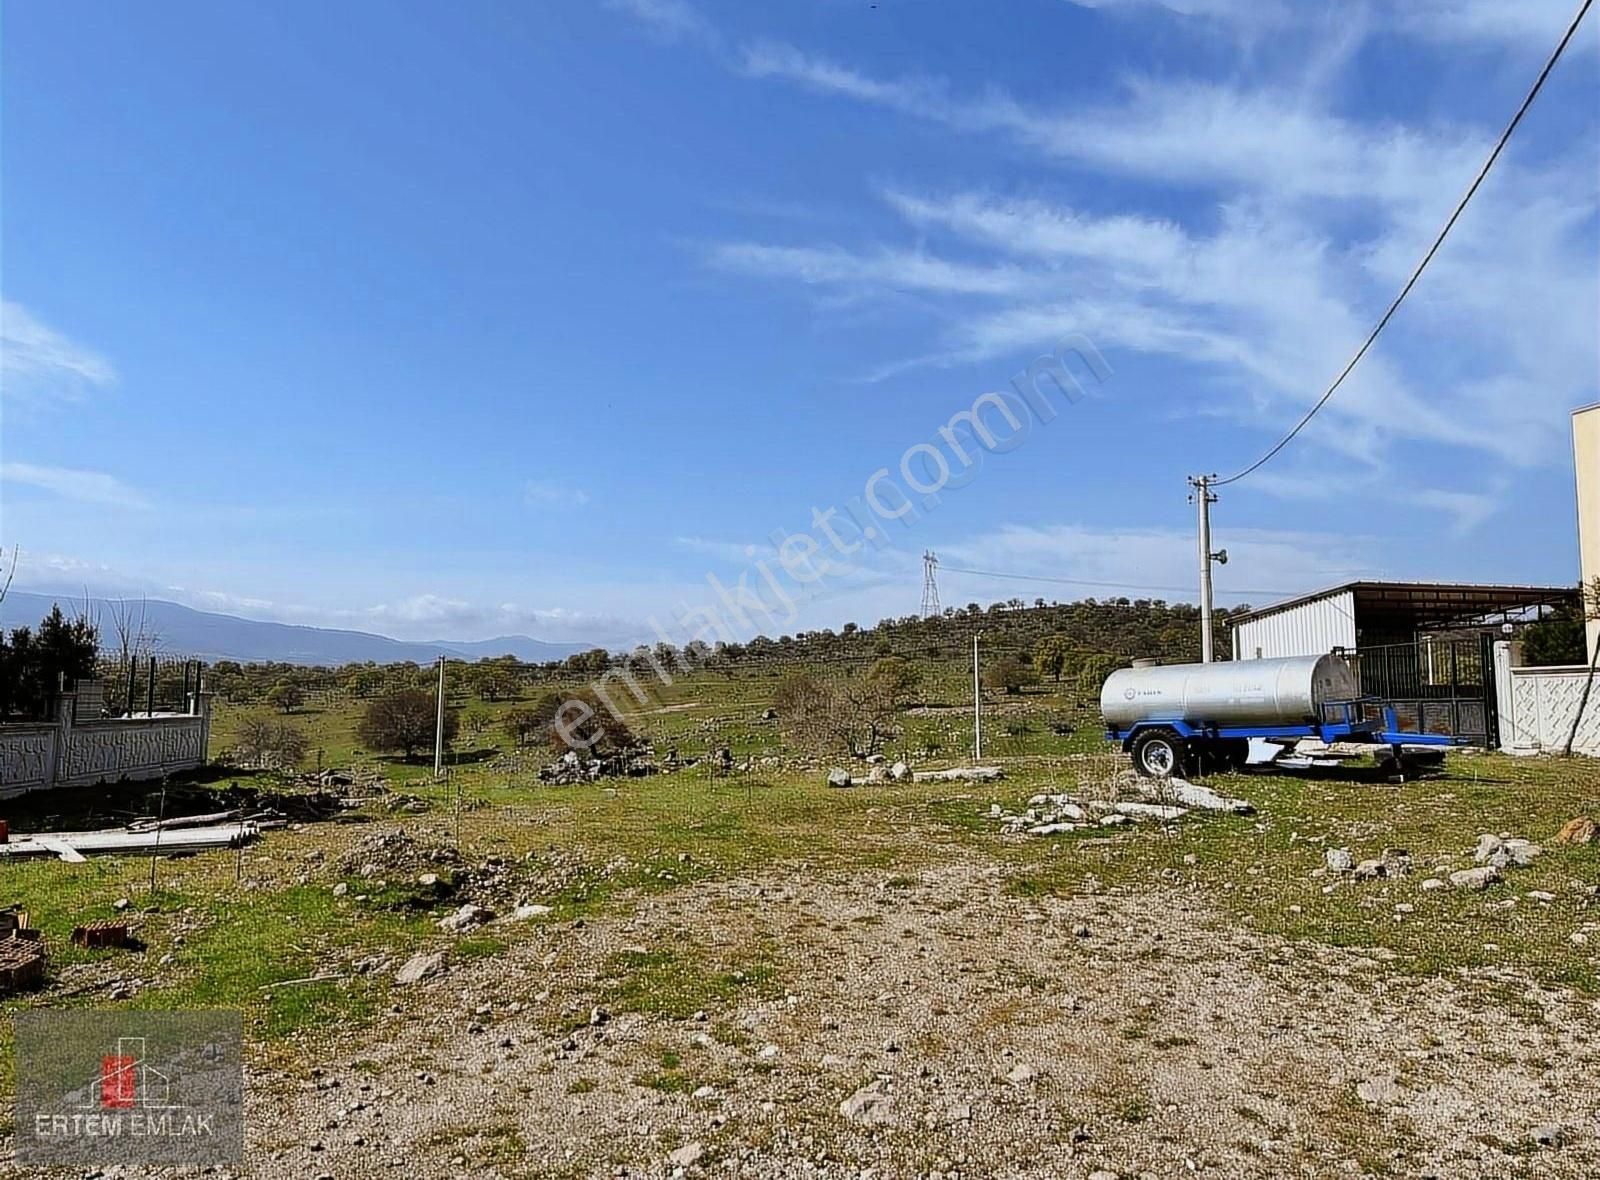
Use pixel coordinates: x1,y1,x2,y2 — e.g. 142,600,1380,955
1101,656,1454,779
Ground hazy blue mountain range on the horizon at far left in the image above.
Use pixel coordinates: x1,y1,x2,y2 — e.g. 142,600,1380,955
0,590,594,665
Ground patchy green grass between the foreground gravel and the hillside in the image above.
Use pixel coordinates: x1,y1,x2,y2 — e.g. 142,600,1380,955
0,665,1600,1170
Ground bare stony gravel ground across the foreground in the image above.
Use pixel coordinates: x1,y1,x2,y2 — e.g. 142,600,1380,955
219,867,1600,1180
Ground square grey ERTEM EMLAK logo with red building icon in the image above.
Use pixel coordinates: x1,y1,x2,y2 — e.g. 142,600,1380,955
16,1012,245,1164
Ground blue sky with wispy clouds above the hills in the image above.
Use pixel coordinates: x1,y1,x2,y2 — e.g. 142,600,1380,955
0,0,1600,643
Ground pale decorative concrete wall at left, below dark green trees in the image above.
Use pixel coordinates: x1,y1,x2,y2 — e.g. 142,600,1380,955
0,692,211,798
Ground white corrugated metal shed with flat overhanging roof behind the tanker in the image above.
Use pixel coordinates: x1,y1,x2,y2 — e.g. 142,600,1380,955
1234,582,1578,660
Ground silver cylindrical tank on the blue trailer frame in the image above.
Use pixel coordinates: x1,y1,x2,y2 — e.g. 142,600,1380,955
1101,656,1362,729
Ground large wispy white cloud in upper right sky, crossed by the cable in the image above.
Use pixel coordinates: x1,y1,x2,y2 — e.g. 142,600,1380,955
710,27,1600,467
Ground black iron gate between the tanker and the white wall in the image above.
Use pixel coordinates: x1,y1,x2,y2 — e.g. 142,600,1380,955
1350,633,1499,747
